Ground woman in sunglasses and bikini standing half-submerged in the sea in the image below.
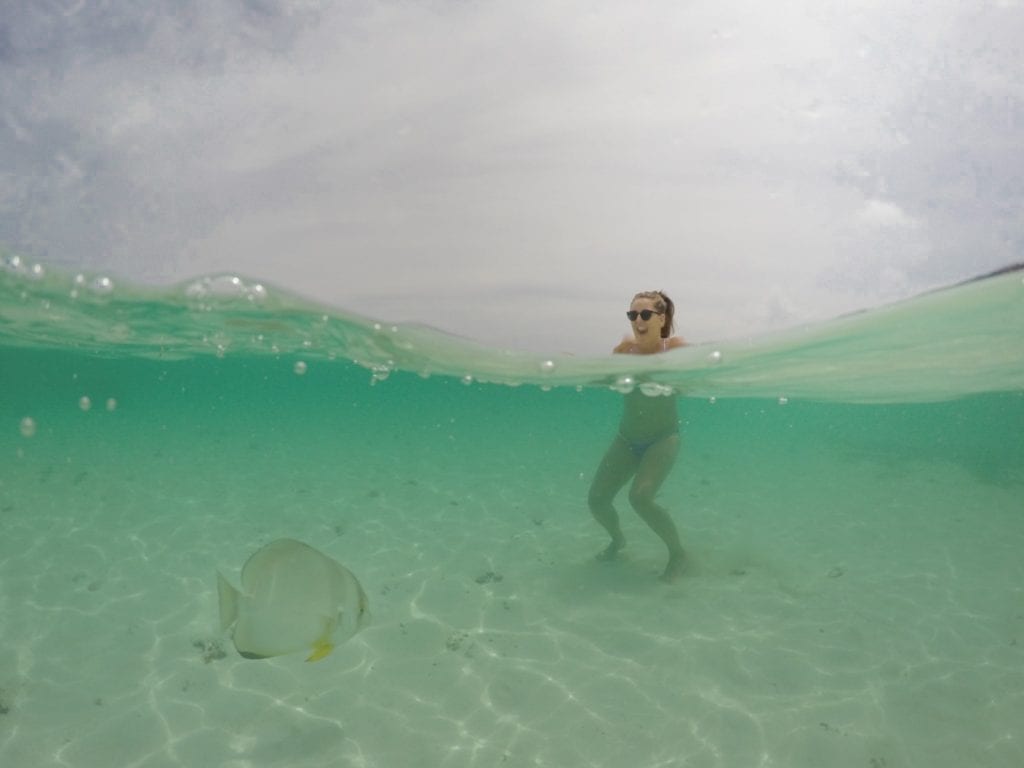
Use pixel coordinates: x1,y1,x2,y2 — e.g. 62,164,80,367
588,291,686,582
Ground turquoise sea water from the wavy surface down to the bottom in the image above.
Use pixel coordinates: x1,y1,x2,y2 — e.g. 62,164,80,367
0,257,1024,768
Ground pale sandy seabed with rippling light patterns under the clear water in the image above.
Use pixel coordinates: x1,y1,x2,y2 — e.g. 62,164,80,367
0,403,1024,768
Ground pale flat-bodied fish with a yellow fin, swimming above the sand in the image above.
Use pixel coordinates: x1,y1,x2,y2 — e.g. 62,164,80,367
217,539,370,662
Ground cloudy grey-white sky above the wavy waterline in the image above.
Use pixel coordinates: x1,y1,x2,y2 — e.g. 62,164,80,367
0,0,1024,353
